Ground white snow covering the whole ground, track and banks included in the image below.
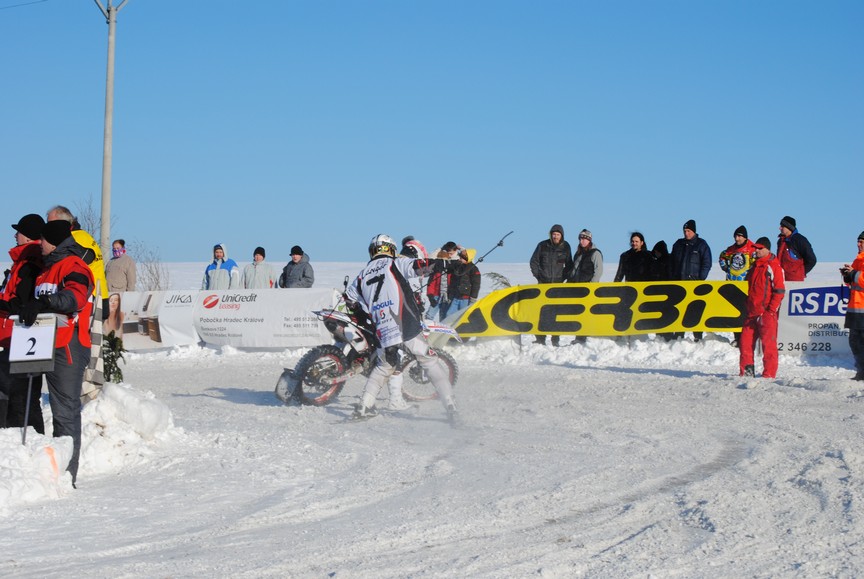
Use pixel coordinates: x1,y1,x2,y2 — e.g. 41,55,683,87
0,264,864,578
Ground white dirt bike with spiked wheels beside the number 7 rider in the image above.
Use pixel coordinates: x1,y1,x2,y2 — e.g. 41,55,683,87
275,309,462,406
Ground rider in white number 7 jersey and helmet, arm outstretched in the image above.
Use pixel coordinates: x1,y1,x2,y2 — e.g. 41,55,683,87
345,234,456,422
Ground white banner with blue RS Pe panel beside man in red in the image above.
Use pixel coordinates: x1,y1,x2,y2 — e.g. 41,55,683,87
777,281,852,356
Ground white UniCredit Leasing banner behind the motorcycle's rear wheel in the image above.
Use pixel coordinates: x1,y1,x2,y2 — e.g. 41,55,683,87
192,288,339,348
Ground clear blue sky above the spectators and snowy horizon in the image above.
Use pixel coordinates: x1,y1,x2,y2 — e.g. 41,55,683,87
0,0,864,269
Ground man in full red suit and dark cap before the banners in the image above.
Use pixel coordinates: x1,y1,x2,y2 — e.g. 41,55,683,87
739,237,786,378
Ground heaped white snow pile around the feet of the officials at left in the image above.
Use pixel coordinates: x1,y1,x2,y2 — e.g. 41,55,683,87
0,383,182,509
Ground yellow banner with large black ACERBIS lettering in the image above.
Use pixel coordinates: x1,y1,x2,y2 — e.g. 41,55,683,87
455,281,747,337
